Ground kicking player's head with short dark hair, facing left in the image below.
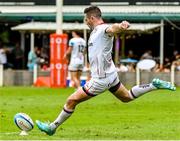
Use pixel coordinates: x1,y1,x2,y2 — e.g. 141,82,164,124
84,6,101,28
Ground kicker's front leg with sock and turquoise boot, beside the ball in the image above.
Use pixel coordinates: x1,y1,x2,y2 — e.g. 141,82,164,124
36,88,92,136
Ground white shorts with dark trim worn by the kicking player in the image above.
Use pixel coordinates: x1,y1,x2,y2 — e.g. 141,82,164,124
83,72,121,96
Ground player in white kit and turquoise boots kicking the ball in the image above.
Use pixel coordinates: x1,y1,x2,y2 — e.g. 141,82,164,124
36,6,176,135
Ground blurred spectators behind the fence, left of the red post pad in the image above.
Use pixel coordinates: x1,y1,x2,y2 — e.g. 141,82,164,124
0,41,49,71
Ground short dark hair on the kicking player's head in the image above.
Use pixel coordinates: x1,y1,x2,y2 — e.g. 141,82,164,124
84,6,101,18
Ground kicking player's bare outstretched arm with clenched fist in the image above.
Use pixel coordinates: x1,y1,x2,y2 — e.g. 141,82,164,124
106,21,130,34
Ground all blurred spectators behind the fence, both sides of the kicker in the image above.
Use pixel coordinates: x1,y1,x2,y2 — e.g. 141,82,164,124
0,41,180,72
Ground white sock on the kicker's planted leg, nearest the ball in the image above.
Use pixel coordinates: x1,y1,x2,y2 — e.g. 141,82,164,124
50,106,74,130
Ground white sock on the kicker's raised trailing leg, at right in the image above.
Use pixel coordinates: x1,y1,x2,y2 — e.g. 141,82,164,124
129,83,157,99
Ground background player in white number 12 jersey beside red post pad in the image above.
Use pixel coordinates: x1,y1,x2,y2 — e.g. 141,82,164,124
64,31,86,89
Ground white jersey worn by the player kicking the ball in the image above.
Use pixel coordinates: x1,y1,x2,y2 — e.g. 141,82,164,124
88,24,116,78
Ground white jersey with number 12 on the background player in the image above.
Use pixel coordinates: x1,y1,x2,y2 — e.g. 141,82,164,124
69,38,86,64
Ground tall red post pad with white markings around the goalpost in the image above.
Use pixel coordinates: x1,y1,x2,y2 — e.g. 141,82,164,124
50,34,68,87
